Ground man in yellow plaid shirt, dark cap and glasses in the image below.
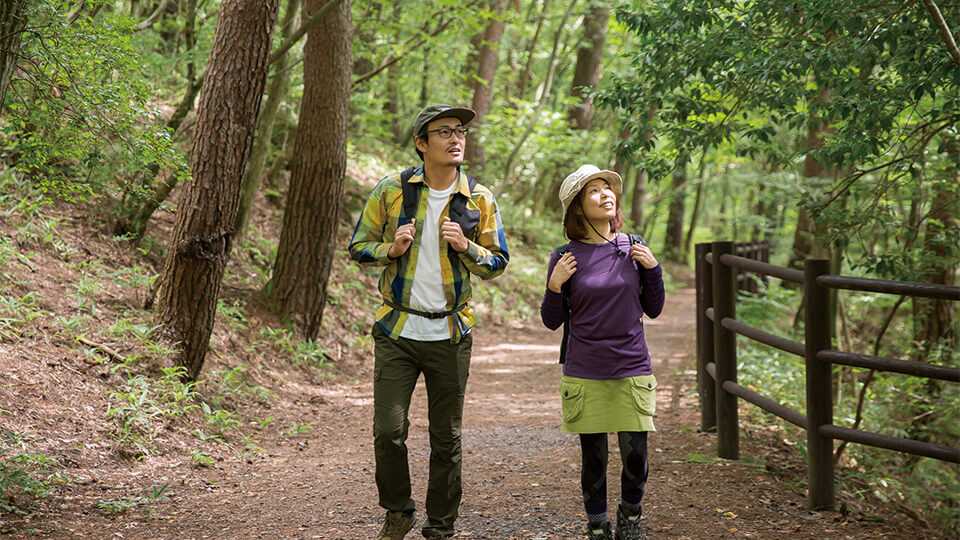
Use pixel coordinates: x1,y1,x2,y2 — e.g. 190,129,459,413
350,105,509,540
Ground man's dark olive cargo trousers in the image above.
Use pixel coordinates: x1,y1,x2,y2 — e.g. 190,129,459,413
373,324,473,533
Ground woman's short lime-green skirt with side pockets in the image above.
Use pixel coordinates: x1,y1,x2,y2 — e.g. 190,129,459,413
560,375,657,433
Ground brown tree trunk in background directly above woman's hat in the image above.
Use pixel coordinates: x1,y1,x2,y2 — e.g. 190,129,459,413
567,2,610,129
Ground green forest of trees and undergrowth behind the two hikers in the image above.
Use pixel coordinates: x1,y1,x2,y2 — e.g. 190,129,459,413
0,0,960,533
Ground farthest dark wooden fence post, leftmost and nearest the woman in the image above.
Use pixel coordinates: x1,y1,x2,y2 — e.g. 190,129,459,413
695,243,717,432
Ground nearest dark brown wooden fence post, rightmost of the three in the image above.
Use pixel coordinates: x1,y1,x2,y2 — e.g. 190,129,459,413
803,259,833,510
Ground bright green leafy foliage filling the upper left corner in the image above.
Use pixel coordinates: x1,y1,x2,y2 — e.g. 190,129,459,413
0,0,186,210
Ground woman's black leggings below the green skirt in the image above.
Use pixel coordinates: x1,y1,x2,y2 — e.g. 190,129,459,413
580,431,648,515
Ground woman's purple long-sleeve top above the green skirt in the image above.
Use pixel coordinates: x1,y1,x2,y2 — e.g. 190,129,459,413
540,234,665,379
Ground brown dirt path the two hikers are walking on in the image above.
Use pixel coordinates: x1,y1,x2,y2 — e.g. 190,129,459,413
7,289,921,540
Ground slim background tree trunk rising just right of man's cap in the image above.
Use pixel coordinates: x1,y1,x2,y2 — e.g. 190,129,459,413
465,0,506,172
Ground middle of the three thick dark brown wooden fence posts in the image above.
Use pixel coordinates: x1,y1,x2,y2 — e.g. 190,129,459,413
712,242,740,459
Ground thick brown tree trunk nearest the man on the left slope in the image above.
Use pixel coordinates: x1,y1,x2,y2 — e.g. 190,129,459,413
267,0,352,340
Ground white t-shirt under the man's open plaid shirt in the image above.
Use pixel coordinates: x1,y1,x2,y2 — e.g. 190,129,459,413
400,179,459,341
